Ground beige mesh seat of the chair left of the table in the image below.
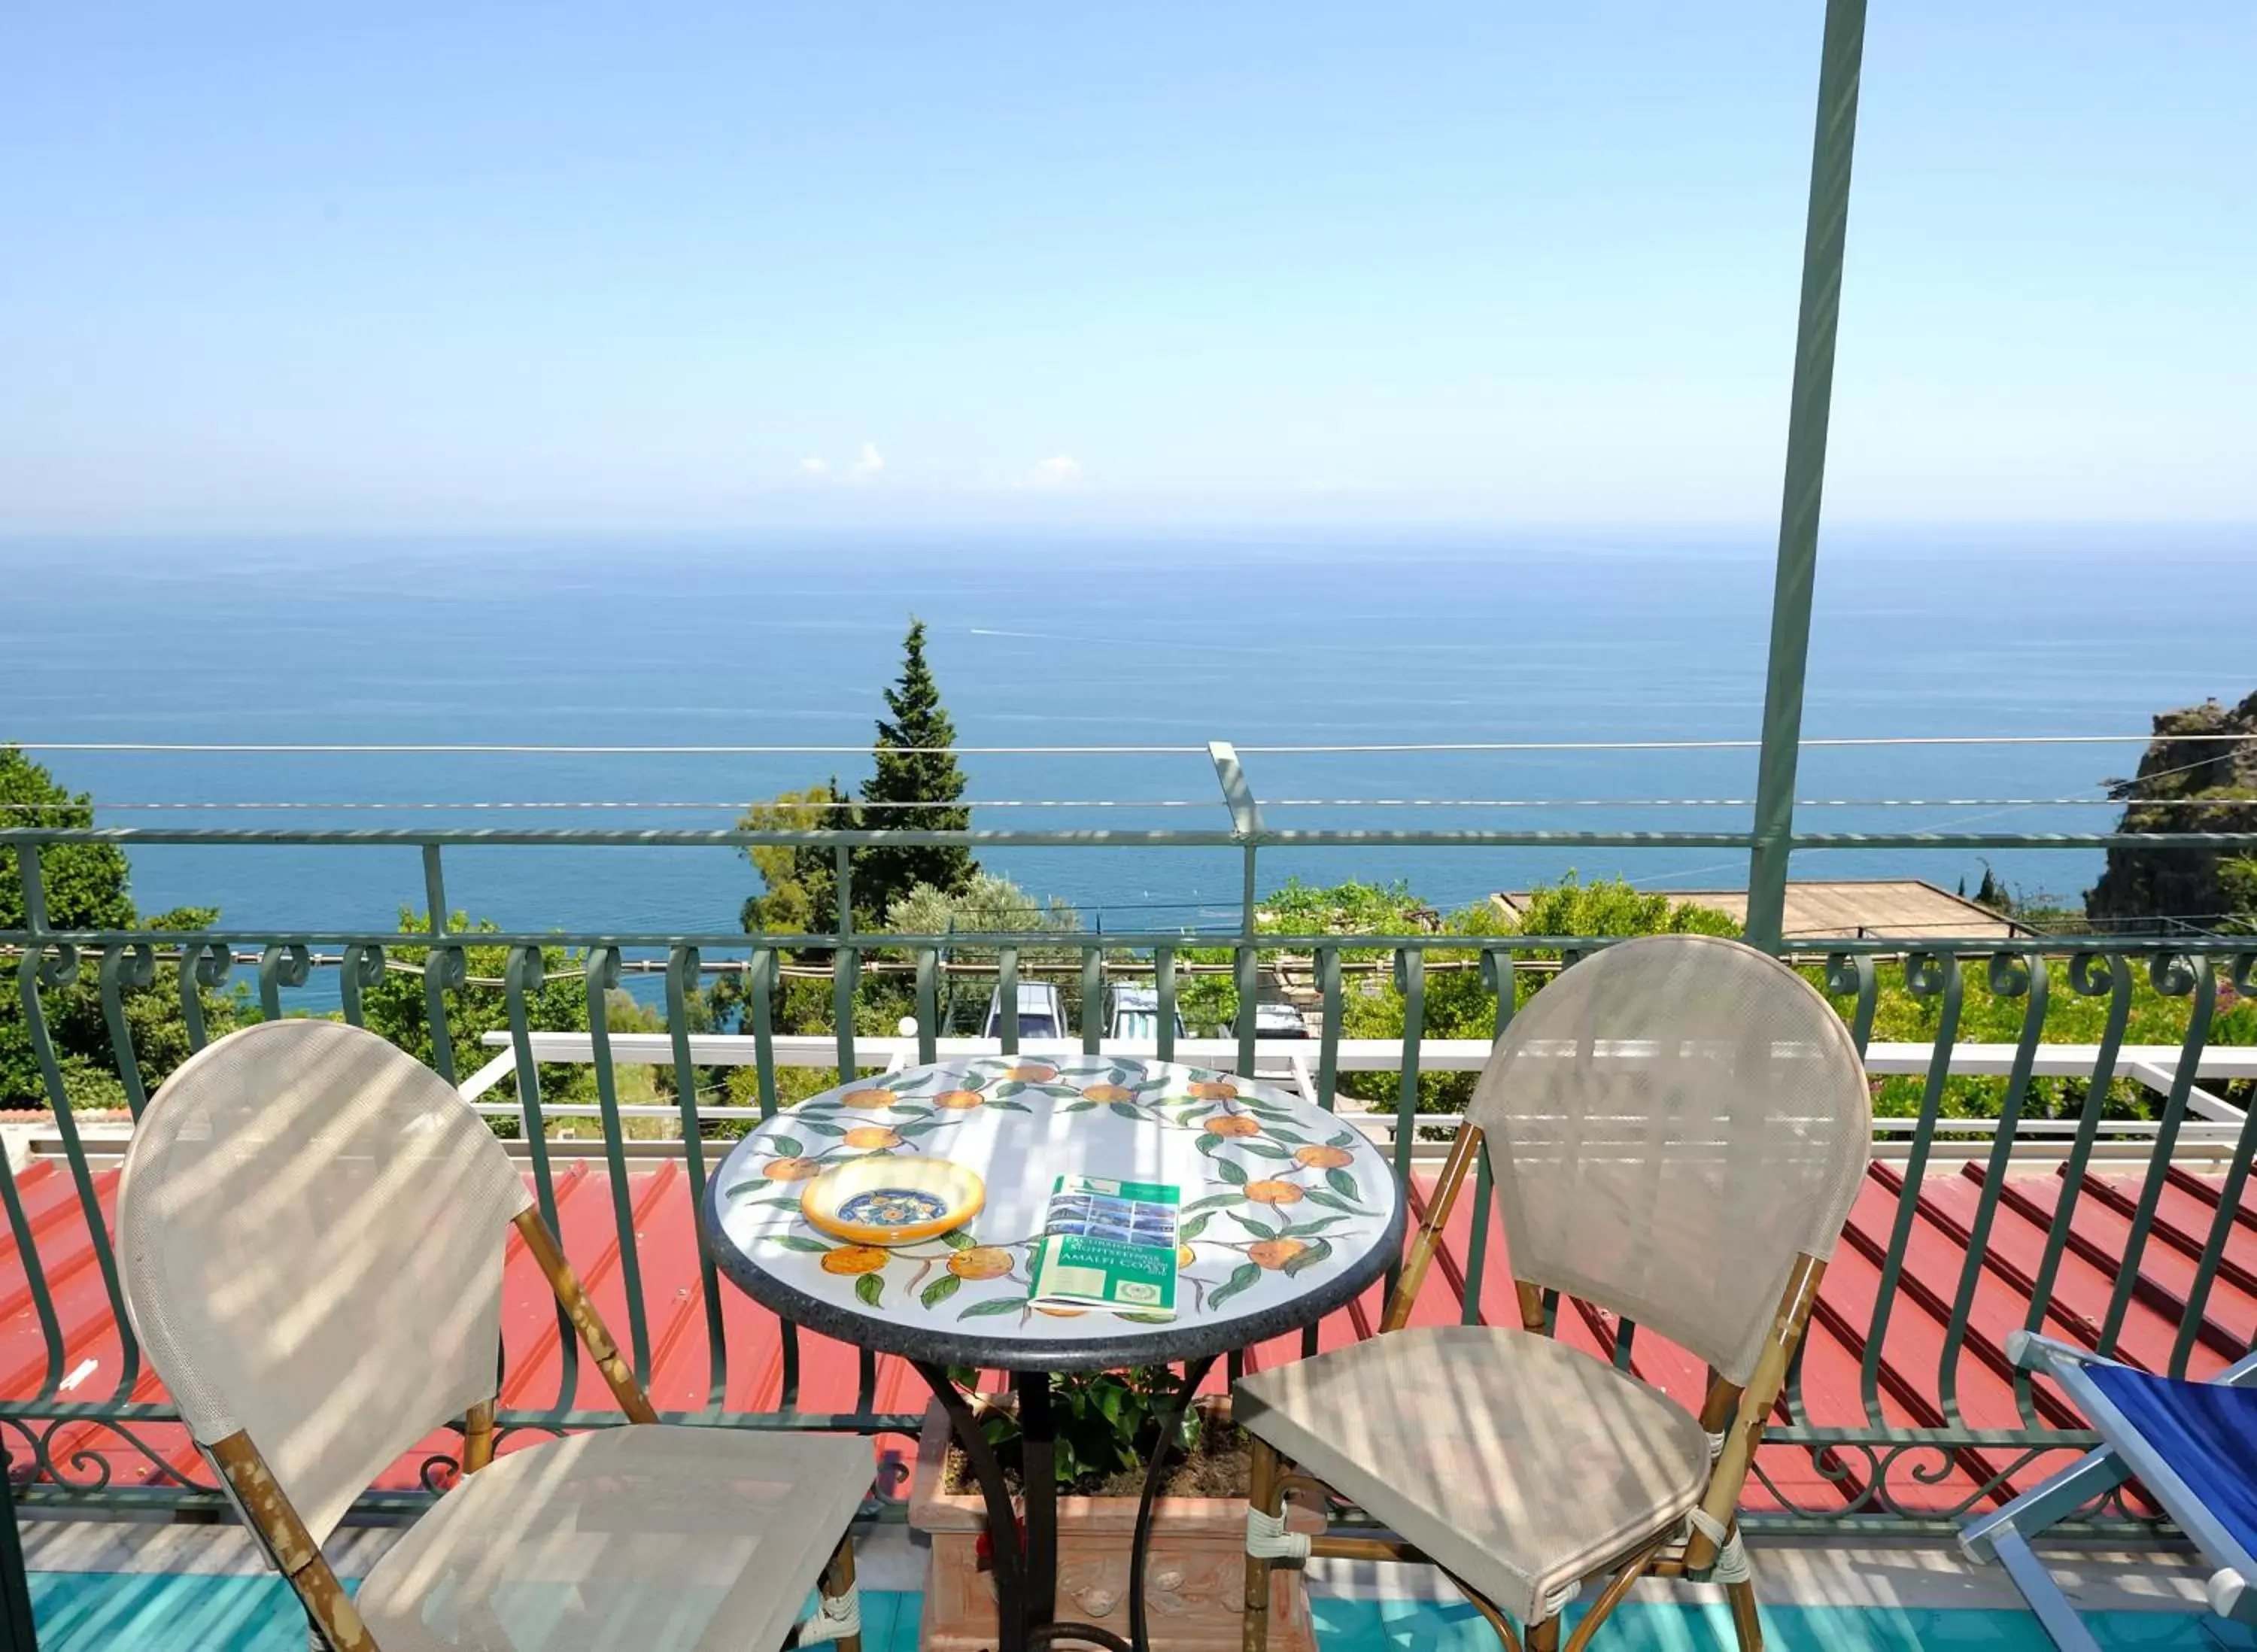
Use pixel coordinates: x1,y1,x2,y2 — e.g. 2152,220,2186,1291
359,1424,871,1652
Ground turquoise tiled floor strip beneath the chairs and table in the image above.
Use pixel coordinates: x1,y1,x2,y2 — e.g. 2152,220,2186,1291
32,1571,2257,1652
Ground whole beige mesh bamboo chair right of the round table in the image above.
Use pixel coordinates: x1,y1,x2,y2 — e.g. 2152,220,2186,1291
1235,934,1871,1652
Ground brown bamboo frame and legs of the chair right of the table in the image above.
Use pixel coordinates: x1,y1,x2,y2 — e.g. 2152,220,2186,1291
1241,1122,1826,1652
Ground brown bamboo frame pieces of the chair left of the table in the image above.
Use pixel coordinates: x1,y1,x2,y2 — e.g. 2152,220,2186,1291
203,1210,862,1652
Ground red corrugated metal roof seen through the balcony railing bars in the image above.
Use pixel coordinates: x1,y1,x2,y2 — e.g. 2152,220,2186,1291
0,1160,2257,1510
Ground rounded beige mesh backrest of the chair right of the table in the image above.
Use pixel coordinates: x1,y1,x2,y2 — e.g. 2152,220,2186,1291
1469,934,1871,1383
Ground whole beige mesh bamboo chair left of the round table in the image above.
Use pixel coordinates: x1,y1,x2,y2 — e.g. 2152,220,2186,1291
117,1020,871,1652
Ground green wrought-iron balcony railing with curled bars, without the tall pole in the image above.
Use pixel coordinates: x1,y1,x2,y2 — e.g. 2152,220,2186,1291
0,826,2257,1530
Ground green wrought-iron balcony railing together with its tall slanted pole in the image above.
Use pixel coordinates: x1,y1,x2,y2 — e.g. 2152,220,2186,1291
0,0,2257,1562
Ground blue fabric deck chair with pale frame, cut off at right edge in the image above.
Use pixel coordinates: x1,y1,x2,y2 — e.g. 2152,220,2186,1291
1959,1332,2257,1652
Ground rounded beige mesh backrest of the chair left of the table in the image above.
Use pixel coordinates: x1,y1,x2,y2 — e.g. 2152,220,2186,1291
117,1020,530,1541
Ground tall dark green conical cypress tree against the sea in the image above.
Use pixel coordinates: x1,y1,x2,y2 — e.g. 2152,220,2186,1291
853,616,980,928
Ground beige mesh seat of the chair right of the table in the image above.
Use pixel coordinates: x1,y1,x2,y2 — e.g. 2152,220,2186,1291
1235,1325,1709,1623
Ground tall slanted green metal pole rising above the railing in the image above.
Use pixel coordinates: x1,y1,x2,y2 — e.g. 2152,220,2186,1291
1747,0,1864,952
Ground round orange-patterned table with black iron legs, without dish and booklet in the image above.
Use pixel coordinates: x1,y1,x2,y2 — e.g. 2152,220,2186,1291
702,1056,1404,1652
